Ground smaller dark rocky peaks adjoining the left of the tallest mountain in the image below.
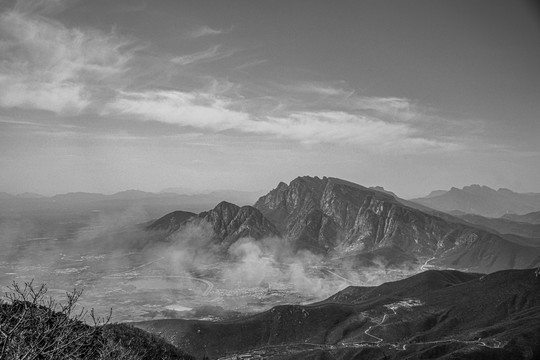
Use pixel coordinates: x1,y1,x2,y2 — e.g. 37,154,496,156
147,201,280,250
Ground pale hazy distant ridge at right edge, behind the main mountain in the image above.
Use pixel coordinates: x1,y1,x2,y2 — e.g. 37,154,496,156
412,185,540,217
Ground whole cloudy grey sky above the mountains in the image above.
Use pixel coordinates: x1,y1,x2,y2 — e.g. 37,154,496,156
0,0,540,198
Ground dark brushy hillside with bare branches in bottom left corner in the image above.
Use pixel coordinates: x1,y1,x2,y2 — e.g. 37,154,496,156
0,283,194,360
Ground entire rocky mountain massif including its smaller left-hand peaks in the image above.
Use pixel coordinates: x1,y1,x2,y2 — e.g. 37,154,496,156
149,176,540,272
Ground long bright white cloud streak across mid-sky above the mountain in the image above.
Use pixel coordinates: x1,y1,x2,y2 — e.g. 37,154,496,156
106,91,451,150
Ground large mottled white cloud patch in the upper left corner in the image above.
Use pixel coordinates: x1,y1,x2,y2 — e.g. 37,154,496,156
0,5,132,113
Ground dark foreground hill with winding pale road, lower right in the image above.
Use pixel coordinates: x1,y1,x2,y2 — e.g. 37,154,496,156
135,270,540,360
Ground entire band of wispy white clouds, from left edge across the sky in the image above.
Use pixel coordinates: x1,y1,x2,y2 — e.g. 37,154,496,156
0,0,468,151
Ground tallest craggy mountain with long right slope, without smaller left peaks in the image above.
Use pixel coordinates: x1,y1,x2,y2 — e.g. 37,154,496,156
254,177,540,271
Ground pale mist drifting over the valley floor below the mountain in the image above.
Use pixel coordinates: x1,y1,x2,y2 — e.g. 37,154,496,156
0,207,418,321
